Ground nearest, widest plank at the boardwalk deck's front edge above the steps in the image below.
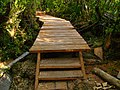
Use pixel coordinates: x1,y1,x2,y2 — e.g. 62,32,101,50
30,45,90,52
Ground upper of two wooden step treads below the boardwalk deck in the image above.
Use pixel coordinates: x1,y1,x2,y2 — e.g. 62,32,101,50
40,58,81,69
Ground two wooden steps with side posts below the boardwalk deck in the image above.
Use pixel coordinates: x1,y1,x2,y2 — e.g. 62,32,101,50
35,51,87,90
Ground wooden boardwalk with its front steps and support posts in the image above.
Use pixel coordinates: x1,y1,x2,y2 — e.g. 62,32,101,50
30,11,90,90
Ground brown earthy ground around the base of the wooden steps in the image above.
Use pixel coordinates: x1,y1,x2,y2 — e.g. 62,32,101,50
0,55,120,90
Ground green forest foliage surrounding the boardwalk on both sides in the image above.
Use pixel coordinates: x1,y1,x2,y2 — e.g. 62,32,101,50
0,0,120,60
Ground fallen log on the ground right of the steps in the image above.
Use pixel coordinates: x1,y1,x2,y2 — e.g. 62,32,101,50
93,68,120,88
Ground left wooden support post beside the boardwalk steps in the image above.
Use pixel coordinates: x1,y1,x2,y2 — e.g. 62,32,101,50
35,53,40,90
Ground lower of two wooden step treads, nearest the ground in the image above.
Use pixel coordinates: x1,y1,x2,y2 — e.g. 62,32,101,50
39,70,83,80
